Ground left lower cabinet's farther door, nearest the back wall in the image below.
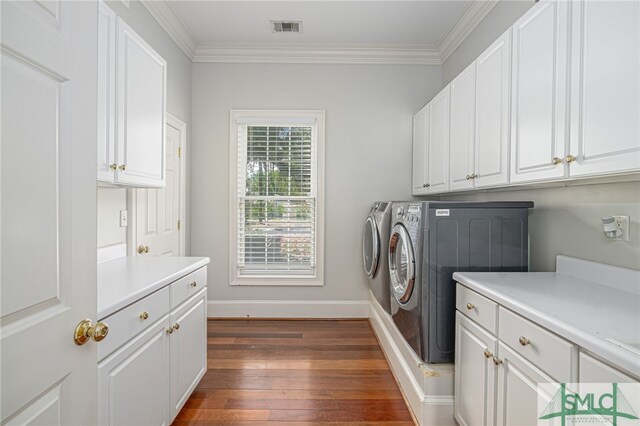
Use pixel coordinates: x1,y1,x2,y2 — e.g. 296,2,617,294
170,289,207,421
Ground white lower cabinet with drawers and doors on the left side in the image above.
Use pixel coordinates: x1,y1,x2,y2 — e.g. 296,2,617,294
98,267,207,426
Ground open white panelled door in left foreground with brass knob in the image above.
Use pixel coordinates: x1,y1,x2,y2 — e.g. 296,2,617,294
0,1,98,425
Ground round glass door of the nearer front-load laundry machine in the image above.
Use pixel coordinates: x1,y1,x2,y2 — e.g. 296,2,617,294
389,223,415,305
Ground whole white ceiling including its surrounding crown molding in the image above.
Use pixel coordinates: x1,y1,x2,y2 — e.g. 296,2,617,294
142,0,497,64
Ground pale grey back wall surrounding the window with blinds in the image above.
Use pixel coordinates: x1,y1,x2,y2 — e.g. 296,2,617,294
191,64,441,300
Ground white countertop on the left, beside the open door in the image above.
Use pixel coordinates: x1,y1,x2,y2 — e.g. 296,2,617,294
98,256,209,320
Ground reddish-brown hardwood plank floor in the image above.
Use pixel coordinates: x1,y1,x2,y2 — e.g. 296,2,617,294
173,320,414,426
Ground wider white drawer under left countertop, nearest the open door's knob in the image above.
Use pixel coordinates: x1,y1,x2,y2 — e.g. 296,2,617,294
98,287,169,360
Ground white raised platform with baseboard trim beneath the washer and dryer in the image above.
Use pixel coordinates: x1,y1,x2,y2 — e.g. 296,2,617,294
369,295,456,426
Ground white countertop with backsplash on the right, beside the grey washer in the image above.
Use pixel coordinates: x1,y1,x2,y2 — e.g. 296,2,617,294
453,256,640,377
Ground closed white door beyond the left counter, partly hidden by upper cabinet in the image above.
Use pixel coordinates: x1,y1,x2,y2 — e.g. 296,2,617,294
135,114,186,256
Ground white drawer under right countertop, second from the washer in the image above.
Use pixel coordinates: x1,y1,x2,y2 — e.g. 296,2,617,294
498,307,577,383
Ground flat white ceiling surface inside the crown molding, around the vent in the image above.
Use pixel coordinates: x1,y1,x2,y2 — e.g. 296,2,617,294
171,1,470,47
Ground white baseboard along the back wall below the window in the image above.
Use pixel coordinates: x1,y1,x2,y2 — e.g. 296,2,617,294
207,300,369,318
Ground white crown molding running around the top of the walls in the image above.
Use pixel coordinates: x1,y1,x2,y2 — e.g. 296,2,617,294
140,0,500,65
